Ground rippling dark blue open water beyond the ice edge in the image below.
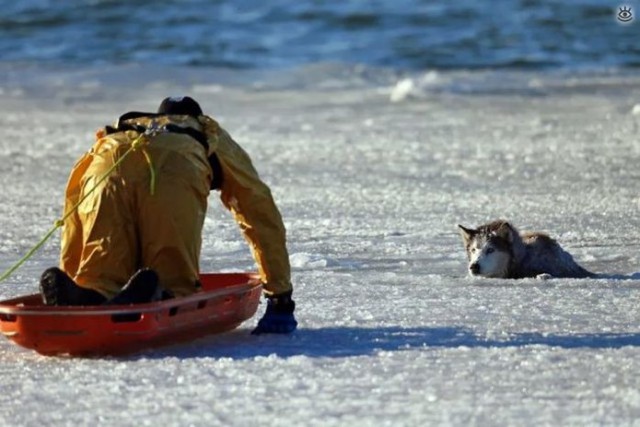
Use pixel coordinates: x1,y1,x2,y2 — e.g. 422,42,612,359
0,0,640,70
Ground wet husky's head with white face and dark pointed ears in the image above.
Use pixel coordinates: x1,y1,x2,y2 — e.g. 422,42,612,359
458,221,515,278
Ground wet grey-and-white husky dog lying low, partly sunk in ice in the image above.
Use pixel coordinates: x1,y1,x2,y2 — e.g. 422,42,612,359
458,220,595,279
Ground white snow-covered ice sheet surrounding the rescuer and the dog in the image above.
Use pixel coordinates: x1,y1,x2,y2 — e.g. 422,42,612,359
0,66,640,426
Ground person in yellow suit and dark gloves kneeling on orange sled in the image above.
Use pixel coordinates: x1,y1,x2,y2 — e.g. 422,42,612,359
40,97,297,333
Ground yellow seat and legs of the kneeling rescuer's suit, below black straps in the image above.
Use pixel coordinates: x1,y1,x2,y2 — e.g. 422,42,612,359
60,132,212,298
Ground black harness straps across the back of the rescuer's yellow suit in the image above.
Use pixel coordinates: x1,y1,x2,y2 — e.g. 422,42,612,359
105,111,224,190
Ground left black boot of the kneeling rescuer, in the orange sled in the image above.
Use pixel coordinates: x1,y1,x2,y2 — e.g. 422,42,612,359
40,267,106,306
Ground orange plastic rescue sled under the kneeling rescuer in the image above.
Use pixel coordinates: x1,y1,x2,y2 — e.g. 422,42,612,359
0,273,262,356
